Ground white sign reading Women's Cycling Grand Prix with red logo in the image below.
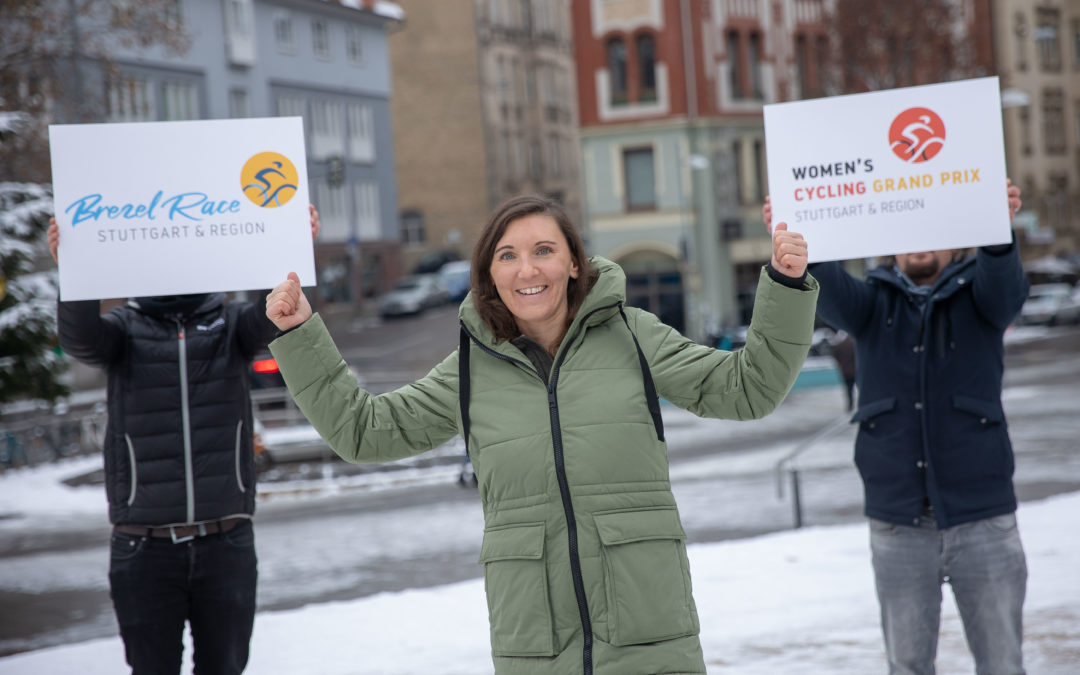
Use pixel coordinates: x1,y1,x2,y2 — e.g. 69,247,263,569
765,78,1012,262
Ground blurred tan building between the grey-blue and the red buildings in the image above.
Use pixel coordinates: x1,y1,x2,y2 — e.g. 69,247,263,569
390,0,580,274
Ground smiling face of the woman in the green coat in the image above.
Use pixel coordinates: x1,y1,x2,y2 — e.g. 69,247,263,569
490,214,580,351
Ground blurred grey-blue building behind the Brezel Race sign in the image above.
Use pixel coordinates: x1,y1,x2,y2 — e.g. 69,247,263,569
41,0,404,303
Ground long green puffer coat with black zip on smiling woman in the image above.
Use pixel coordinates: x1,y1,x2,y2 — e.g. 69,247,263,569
270,258,818,675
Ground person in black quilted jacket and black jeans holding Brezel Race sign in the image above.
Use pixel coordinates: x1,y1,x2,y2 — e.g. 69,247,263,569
49,206,320,675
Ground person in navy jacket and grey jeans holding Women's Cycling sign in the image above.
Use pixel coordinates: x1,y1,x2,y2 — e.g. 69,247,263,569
764,184,1028,675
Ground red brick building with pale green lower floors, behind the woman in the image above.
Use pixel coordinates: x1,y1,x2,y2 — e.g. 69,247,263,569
573,0,828,341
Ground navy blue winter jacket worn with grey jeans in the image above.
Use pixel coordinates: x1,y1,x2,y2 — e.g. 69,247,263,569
810,244,1028,528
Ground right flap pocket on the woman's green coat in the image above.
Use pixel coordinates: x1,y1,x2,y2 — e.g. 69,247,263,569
594,508,698,647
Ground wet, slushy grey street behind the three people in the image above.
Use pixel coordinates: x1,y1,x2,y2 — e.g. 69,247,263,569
0,308,1080,656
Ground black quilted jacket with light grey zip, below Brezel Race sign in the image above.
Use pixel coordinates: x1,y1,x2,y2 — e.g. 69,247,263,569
57,294,275,526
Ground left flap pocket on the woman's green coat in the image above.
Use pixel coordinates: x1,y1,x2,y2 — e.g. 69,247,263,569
480,523,556,657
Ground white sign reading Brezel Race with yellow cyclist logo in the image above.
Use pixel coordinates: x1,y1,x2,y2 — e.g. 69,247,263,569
49,118,315,300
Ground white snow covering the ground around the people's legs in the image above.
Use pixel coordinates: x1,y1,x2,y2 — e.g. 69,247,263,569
0,462,1080,675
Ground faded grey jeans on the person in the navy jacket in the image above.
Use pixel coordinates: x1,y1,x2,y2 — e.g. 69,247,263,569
870,513,1027,675
